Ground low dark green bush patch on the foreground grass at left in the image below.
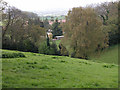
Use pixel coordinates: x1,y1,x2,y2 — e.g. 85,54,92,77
2,52,25,58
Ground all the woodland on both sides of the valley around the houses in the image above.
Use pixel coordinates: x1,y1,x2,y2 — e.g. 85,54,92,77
0,0,120,59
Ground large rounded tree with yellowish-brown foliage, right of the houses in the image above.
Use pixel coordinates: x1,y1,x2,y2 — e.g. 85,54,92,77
62,7,108,59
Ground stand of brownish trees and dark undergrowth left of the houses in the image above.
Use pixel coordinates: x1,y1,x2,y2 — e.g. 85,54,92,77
0,0,46,52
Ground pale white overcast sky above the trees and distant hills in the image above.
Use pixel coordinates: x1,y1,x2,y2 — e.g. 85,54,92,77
5,0,116,11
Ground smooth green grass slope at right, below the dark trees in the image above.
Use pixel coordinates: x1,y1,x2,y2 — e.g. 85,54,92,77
94,45,118,64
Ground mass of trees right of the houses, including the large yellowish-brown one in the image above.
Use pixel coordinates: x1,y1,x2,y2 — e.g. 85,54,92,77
61,2,120,59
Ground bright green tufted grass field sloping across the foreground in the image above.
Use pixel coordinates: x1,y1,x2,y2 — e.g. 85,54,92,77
2,50,118,88
